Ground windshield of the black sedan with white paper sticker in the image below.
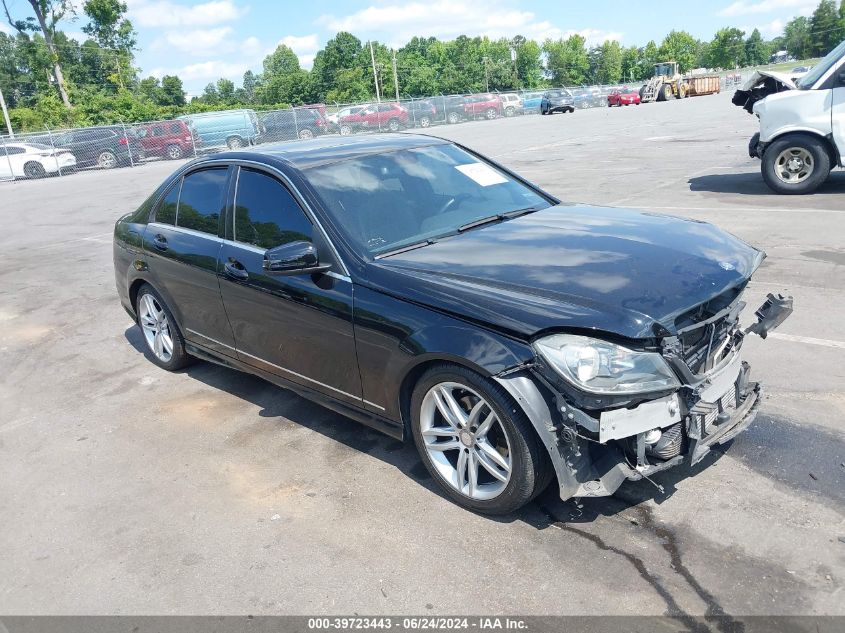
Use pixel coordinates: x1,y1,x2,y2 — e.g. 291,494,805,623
305,145,551,256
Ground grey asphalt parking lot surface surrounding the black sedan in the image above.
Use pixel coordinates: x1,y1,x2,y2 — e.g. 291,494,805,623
0,94,845,616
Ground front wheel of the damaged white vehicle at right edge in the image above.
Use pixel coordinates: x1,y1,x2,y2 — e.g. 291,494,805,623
760,134,830,195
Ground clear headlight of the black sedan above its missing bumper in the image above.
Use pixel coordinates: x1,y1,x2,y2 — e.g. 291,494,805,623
534,334,681,395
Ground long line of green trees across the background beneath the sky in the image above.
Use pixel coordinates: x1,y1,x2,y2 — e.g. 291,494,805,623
0,0,845,131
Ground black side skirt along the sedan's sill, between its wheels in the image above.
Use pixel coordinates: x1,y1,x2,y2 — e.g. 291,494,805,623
185,340,405,442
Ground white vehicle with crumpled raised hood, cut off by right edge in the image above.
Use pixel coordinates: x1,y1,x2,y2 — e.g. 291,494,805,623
733,42,845,195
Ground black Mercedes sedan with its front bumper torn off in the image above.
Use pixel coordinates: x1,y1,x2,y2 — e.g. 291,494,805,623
114,134,791,513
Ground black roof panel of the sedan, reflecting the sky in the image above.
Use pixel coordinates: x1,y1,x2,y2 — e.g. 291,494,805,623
203,133,449,170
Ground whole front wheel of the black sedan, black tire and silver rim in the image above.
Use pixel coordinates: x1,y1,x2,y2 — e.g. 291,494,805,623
411,365,551,514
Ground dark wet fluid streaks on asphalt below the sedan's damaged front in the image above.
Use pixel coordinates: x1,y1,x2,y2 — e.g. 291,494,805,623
539,505,745,633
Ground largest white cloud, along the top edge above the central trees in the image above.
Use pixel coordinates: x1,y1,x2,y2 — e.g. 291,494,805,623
316,0,621,47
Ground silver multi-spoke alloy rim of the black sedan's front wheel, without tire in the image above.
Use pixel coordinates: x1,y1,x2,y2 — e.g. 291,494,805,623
420,382,513,501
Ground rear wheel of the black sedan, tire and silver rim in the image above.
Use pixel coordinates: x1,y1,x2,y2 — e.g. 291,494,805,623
135,284,192,371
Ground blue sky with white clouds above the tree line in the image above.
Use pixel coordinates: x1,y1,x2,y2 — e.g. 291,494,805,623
0,0,818,96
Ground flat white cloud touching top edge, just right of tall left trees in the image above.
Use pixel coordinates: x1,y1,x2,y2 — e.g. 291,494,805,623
127,0,247,29
